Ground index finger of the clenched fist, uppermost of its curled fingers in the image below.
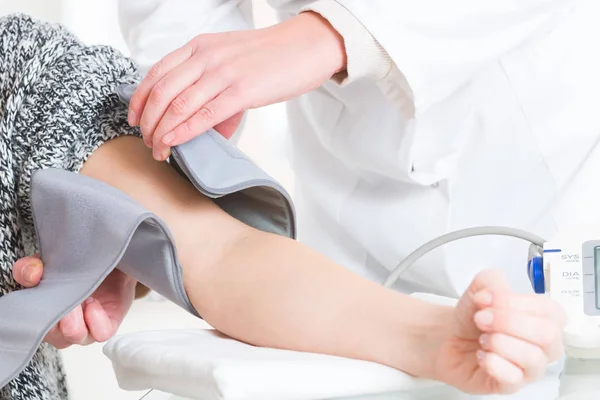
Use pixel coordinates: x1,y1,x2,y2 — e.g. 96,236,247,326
474,308,563,362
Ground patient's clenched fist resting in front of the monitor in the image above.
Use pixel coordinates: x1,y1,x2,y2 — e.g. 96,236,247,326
435,271,566,394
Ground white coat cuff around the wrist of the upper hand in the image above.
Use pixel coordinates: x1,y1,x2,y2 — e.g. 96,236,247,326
300,0,393,85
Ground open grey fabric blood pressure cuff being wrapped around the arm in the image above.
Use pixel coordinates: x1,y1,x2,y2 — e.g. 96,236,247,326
0,83,296,388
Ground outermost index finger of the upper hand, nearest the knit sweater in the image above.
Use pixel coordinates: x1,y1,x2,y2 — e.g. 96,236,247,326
128,43,194,126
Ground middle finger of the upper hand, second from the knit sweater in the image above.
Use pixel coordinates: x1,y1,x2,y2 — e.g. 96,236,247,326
139,55,209,147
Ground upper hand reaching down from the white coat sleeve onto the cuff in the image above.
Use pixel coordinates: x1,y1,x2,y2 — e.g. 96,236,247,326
129,12,346,161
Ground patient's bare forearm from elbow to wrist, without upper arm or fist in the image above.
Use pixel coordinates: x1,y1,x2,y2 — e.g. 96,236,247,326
192,232,450,376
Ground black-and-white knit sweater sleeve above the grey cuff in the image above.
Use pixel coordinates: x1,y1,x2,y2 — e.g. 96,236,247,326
0,14,140,234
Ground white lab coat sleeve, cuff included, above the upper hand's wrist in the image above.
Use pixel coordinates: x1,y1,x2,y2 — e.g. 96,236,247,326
299,0,576,111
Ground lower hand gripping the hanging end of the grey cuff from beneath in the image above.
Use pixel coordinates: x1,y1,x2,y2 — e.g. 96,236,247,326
13,256,136,349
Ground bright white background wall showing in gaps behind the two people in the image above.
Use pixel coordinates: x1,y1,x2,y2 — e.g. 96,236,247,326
0,0,293,400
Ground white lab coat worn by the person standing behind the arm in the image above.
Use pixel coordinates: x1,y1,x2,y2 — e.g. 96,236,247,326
121,0,600,295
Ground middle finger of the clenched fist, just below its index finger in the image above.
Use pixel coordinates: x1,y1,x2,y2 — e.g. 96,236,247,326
480,333,548,384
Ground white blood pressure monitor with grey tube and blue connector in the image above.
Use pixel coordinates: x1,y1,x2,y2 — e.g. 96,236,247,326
383,226,600,360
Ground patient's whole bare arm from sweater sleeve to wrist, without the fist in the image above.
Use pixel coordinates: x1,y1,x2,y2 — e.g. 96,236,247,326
82,138,450,376
